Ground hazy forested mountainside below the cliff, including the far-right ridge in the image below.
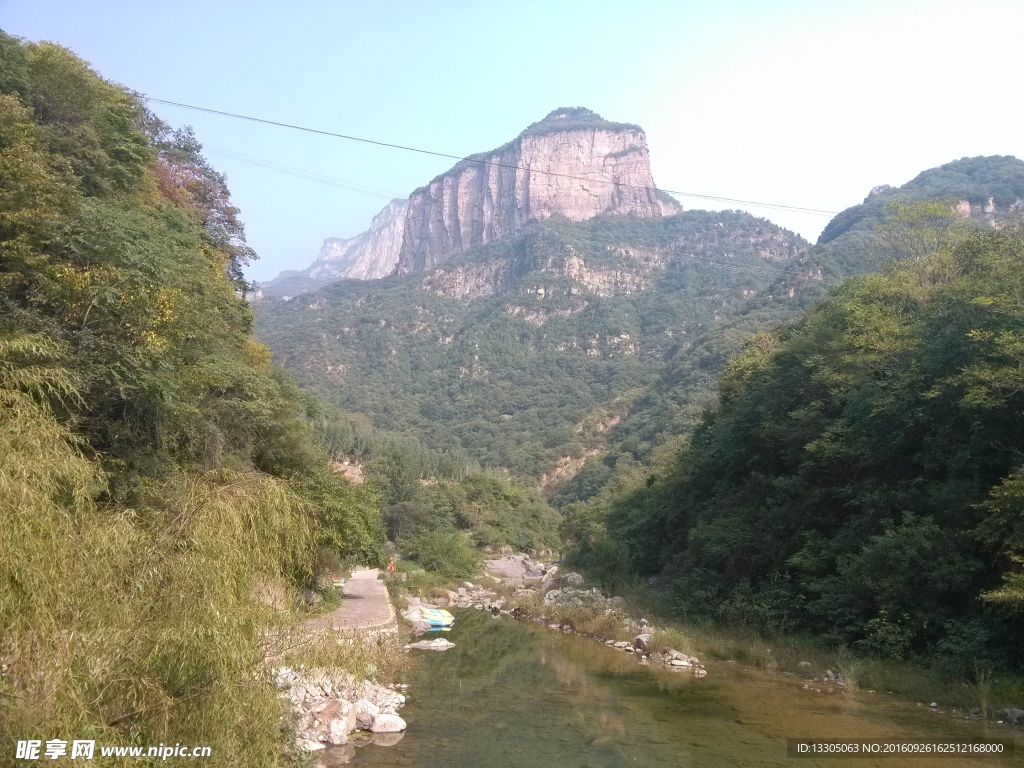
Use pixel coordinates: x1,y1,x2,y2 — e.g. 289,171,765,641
255,158,1024,487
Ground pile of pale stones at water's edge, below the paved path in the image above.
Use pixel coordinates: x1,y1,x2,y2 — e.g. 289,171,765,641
274,667,408,752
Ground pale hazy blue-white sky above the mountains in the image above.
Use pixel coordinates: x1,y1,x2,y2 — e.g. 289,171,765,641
0,0,1024,280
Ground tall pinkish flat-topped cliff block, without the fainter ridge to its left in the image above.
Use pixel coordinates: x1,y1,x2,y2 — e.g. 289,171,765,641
397,110,680,274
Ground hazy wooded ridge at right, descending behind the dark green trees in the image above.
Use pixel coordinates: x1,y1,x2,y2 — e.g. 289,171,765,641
559,157,1024,503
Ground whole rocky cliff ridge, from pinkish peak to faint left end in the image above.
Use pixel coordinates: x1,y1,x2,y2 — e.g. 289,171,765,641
258,108,680,298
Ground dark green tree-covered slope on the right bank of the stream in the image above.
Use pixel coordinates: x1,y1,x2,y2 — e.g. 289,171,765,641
567,221,1024,671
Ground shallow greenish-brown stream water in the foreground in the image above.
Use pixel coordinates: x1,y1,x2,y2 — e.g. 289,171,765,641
333,610,1024,768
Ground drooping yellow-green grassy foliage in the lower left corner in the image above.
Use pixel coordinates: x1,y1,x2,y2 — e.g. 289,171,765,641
0,337,313,766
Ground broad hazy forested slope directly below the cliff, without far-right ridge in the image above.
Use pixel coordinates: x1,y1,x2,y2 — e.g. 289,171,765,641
255,211,819,480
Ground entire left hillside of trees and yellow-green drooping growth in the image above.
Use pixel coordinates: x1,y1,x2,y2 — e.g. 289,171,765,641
0,33,385,765
